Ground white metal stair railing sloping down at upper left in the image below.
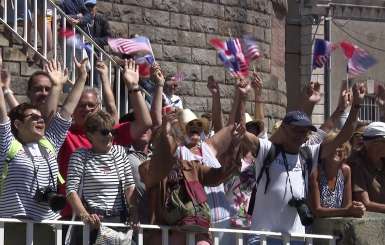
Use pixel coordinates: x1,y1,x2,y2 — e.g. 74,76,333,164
0,0,141,116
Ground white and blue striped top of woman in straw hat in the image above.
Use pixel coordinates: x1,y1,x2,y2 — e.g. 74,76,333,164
177,142,231,223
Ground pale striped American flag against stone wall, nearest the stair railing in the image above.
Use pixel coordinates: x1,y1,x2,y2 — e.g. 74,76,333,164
108,36,153,54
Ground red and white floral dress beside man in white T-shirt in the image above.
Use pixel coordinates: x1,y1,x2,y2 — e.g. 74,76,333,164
225,157,256,229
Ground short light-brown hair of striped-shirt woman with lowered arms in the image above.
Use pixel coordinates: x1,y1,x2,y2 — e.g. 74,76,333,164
84,110,115,133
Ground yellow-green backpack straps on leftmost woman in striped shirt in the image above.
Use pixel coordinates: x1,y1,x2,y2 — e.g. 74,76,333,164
0,137,65,196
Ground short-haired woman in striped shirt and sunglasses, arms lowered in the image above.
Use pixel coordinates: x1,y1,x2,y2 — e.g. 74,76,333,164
67,110,137,244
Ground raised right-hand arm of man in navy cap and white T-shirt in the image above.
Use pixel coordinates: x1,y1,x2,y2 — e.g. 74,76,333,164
321,83,365,158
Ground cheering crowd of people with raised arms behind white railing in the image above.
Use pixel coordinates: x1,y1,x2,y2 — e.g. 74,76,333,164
0,0,385,245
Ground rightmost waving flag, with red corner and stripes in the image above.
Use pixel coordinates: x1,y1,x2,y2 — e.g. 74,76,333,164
340,41,377,76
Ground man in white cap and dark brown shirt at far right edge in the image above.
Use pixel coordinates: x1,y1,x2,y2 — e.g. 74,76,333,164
352,122,385,213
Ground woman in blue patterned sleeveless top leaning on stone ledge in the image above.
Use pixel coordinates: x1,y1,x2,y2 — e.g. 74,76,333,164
310,132,365,217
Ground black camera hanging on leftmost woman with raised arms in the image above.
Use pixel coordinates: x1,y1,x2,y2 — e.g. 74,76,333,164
34,186,66,212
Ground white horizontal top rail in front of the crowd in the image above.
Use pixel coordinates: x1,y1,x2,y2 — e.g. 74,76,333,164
0,218,336,240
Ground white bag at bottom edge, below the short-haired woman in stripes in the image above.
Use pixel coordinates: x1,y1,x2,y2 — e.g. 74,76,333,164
94,225,133,245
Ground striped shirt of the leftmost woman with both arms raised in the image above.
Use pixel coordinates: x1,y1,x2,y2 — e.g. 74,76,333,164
0,114,71,220
